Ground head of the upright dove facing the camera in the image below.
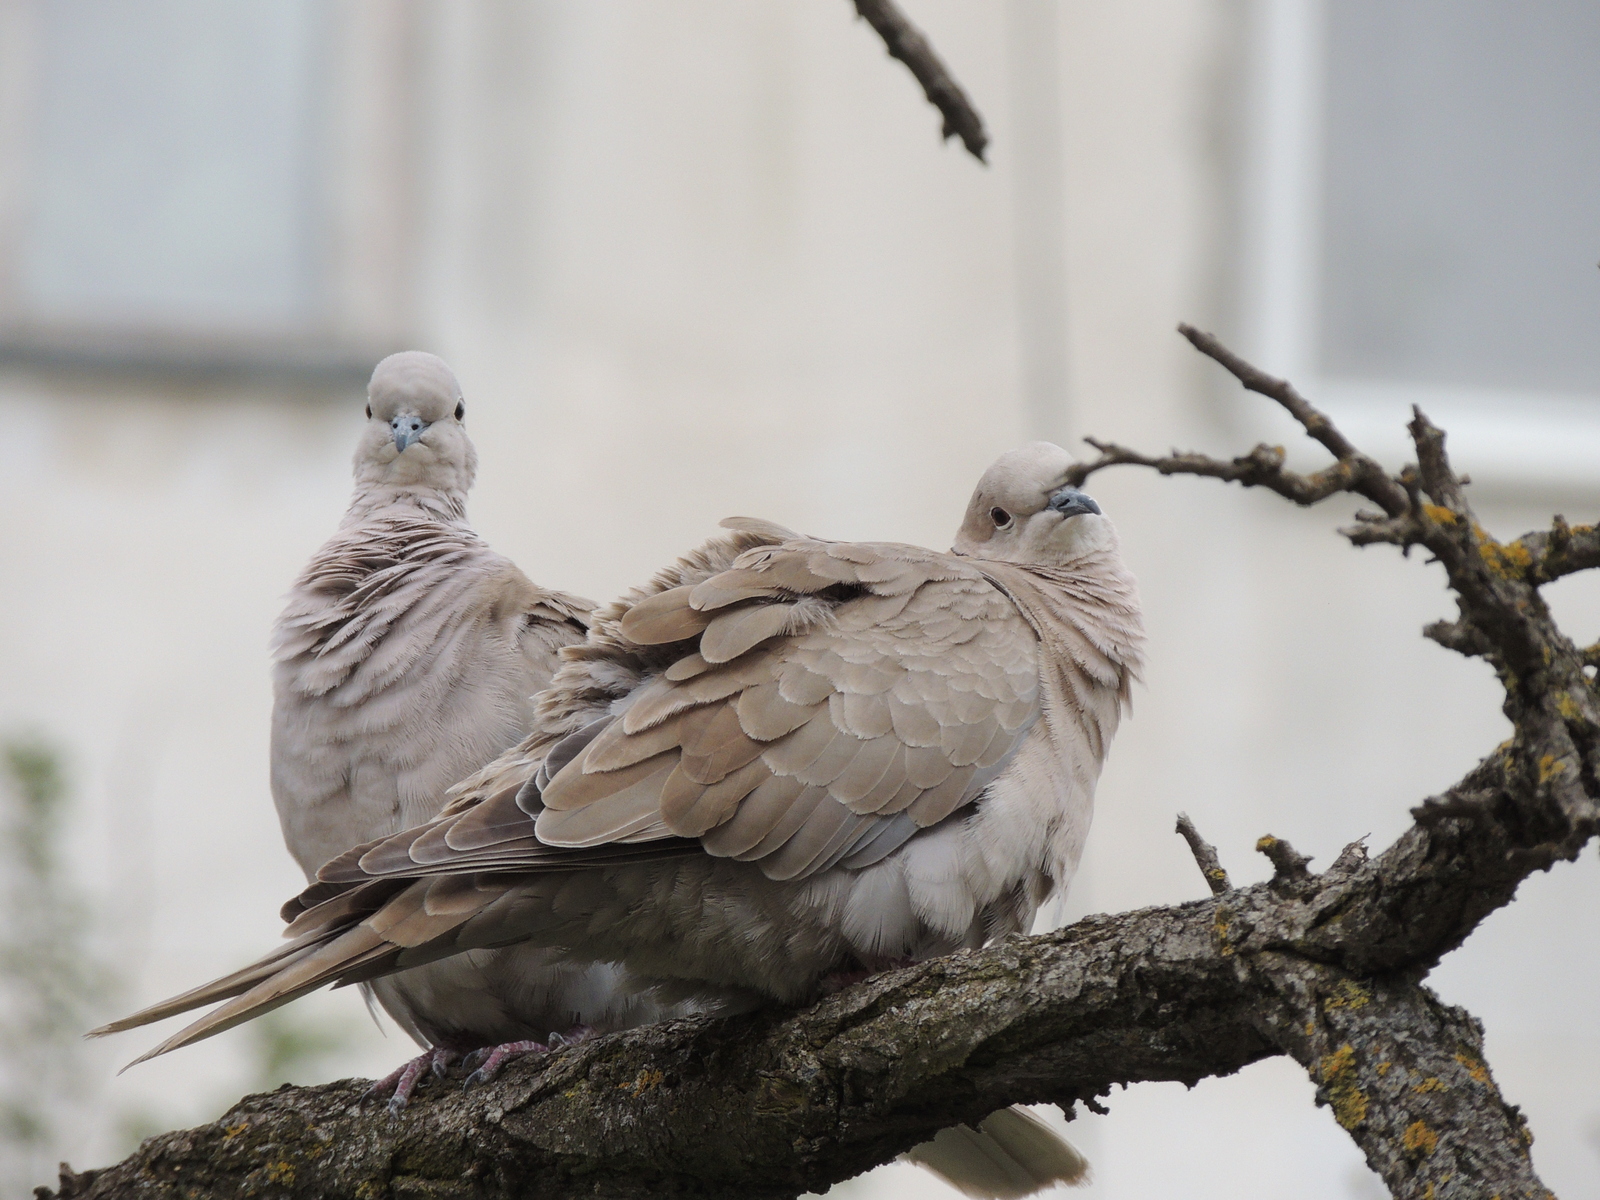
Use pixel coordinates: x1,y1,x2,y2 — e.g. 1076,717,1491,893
355,350,478,507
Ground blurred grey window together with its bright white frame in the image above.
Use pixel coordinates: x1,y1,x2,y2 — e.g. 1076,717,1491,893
1240,0,1600,486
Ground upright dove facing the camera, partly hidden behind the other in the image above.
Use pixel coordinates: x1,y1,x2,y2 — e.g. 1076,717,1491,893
272,350,658,1106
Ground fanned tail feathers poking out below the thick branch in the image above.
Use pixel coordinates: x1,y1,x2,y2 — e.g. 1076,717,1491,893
904,1107,1090,1200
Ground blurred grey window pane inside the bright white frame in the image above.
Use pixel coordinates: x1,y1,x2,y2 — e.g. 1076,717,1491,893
1318,0,1600,394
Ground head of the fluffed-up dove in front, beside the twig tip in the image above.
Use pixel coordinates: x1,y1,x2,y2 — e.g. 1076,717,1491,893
952,442,1117,566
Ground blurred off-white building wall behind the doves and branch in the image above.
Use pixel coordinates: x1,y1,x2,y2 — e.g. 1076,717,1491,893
0,0,1600,1200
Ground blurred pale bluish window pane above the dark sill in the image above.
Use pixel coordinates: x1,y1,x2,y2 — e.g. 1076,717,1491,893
13,0,328,333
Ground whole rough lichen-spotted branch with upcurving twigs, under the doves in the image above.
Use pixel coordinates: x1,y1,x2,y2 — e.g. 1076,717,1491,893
38,328,1600,1200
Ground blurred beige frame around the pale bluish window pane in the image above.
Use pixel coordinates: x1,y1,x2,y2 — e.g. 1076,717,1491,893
0,0,426,387
